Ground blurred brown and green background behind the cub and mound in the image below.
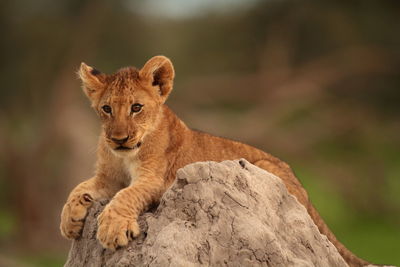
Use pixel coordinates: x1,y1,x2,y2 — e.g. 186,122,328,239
0,0,400,266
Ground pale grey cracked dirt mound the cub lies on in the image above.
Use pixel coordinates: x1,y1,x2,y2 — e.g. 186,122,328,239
65,159,347,267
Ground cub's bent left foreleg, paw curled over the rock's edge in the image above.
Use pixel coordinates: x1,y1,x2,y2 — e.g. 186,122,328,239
60,177,115,239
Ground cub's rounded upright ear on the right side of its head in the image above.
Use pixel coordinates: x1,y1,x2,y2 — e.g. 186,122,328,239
139,56,175,102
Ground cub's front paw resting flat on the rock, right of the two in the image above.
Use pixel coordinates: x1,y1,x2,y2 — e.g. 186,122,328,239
97,203,140,250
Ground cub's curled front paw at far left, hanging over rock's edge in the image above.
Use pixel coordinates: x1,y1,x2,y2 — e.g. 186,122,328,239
60,194,93,239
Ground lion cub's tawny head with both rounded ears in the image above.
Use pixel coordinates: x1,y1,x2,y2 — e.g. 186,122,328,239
79,56,174,155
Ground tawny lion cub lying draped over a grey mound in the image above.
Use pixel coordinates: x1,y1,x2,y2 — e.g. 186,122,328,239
60,56,364,265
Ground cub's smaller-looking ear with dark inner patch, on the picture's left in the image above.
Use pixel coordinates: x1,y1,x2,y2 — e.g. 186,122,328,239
78,62,105,101
